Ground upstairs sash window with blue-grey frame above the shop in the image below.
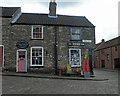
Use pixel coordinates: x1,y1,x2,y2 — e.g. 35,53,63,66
71,27,81,40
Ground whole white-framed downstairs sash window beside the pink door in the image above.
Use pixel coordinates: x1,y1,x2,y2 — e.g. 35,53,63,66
31,47,43,66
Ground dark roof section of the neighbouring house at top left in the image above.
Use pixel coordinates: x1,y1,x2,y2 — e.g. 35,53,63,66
0,7,20,17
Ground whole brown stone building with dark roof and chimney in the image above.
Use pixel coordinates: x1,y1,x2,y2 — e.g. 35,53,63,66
2,1,95,74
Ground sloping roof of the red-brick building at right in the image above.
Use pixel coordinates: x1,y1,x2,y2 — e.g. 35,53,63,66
96,36,120,51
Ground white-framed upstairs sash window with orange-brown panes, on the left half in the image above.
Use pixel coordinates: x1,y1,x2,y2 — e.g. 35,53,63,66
32,26,43,39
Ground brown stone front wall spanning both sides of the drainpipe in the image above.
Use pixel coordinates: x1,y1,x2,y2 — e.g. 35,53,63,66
3,23,95,74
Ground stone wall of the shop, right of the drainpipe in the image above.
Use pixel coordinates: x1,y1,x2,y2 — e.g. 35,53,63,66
57,26,95,73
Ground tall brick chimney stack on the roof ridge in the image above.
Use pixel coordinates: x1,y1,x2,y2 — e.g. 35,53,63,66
49,0,57,17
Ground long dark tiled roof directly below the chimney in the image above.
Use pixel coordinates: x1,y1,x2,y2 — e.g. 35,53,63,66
15,13,95,27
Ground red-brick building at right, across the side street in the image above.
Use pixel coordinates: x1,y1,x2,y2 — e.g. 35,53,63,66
94,36,120,69
